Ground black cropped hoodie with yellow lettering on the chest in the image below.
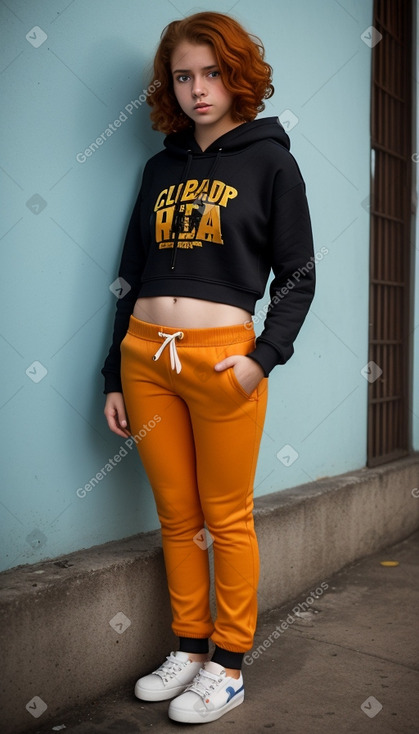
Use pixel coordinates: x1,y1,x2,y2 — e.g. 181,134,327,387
102,117,315,393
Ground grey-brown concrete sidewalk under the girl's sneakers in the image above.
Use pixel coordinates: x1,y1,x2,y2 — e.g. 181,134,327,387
32,533,419,734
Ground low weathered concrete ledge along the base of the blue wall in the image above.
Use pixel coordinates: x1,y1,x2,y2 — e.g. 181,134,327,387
0,454,419,734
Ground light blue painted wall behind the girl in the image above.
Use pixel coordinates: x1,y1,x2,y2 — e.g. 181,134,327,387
0,0,374,569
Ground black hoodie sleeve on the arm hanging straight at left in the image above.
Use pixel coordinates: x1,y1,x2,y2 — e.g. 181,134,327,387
101,170,147,394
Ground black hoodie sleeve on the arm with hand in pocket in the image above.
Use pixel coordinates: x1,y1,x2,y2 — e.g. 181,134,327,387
248,170,315,377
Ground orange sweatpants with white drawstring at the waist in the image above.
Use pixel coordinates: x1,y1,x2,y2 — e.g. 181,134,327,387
121,316,268,652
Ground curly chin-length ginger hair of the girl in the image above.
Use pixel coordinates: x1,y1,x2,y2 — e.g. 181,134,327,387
147,12,274,134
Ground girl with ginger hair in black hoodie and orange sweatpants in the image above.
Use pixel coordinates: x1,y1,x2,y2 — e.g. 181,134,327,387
102,12,314,723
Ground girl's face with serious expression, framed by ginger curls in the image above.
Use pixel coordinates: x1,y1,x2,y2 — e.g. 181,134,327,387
171,41,239,139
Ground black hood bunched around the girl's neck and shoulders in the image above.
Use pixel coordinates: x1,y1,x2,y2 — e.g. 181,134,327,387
164,117,290,158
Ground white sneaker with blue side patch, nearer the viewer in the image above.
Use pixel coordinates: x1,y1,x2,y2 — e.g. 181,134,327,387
169,660,244,724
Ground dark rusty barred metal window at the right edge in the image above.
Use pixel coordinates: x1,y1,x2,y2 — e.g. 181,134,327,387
367,0,412,466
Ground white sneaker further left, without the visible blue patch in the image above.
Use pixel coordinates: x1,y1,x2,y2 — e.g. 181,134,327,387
134,650,202,701
